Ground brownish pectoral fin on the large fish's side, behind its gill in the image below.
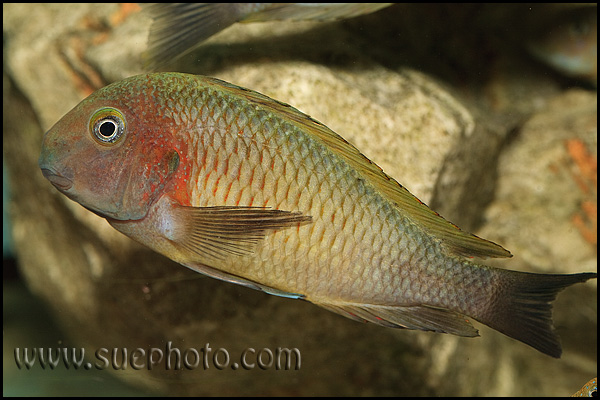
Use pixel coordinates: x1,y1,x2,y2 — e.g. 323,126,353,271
169,205,312,262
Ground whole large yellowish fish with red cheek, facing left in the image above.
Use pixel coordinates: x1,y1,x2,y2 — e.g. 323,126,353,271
39,73,596,357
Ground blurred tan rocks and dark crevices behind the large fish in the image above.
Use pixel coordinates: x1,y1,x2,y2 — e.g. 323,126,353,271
3,4,597,396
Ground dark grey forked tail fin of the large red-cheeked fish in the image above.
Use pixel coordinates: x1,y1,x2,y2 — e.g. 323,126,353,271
473,270,597,358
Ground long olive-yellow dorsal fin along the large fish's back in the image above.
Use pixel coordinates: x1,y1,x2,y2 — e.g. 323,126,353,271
207,78,512,258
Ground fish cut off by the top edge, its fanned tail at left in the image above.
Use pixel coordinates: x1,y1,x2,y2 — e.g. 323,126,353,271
141,3,392,69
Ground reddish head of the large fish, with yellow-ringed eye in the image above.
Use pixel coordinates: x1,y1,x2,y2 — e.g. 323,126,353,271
39,75,179,220
